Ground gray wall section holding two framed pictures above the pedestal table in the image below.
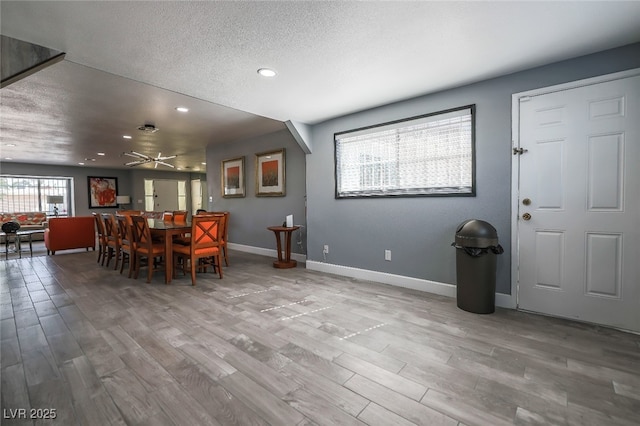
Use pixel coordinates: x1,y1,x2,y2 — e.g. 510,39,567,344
207,126,306,253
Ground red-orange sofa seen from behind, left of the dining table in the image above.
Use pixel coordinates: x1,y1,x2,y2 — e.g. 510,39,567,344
44,216,96,254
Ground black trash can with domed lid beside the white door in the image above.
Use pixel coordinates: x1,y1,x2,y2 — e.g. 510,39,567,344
451,219,504,314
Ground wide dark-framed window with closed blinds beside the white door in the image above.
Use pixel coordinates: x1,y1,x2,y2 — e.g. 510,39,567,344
334,105,475,198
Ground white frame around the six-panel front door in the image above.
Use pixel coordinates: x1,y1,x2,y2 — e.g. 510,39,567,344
510,68,640,309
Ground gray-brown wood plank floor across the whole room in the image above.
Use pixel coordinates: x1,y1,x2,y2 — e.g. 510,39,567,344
0,252,640,426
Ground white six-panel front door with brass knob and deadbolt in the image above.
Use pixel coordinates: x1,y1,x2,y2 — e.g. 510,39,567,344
514,75,640,332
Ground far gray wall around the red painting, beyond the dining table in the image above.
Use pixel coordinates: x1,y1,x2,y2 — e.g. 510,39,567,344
0,162,199,216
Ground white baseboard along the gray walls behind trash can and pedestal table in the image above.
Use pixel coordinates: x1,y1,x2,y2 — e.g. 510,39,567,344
229,243,516,309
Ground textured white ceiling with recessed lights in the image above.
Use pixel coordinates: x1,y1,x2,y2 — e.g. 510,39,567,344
0,0,640,169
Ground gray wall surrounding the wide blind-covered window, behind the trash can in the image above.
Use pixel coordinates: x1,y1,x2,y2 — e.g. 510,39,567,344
307,43,640,294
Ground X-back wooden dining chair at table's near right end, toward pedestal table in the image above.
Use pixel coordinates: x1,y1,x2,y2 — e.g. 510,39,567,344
173,215,224,285
